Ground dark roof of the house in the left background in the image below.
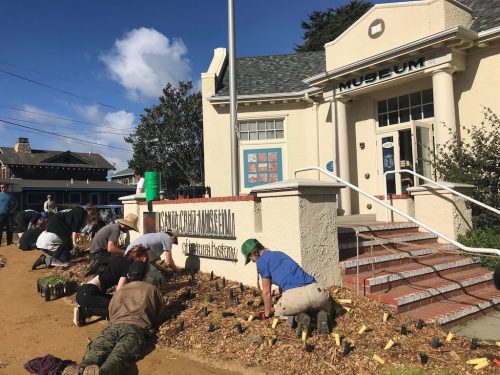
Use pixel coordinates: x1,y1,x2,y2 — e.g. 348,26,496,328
0,147,114,169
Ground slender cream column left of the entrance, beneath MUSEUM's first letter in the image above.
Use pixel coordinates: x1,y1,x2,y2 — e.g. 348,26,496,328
334,98,351,215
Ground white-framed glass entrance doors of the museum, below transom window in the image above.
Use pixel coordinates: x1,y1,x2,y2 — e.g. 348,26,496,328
377,121,432,194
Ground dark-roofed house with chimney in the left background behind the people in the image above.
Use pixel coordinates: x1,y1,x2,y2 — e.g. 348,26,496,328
0,138,135,210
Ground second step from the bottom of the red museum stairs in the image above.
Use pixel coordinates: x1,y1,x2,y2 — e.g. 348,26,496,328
368,268,493,312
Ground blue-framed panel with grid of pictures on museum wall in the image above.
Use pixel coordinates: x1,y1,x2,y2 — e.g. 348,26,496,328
243,148,283,188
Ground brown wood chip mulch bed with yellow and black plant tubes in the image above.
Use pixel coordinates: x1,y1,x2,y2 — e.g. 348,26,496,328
37,238,500,375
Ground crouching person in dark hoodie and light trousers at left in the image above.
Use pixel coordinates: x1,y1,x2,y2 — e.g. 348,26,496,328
31,203,99,270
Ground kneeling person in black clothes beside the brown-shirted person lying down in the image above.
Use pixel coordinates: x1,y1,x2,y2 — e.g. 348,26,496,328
73,245,148,326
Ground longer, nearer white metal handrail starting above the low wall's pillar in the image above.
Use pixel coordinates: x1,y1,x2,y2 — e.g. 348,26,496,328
294,167,500,256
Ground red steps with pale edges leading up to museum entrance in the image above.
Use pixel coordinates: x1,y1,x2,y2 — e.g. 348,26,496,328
338,221,500,325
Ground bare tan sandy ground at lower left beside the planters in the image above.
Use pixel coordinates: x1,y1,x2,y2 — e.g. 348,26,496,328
0,245,246,375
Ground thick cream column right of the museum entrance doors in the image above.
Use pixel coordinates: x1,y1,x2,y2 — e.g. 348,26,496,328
432,68,457,145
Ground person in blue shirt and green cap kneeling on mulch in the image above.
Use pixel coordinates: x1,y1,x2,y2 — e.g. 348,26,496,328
241,238,331,333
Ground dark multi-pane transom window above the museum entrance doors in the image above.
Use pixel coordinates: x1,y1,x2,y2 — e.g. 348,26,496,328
377,89,434,127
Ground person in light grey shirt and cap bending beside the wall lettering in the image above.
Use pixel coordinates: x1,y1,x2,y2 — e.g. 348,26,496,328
125,229,178,272
